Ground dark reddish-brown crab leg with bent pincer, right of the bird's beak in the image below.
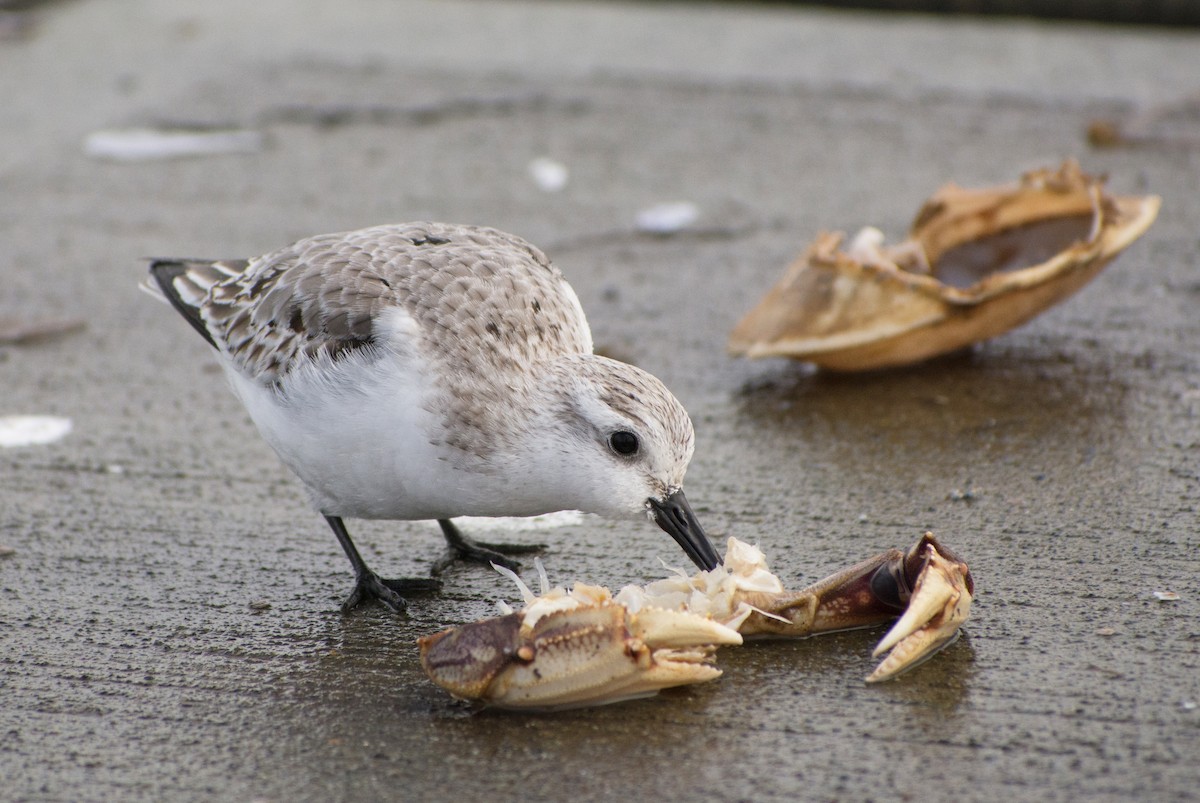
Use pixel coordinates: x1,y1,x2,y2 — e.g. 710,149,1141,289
738,533,974,683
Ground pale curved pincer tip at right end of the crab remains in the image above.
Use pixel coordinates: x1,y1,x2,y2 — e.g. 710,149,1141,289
866,534,973,683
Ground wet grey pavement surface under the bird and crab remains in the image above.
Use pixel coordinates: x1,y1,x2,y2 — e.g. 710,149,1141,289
0,0,1200,801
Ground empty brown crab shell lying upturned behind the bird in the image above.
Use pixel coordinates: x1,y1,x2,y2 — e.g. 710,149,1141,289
730,161,1160,371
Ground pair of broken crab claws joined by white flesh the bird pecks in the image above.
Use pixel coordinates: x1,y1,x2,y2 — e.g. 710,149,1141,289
419,533,974,711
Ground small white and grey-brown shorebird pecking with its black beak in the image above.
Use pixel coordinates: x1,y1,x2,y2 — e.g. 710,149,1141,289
143,223,719,611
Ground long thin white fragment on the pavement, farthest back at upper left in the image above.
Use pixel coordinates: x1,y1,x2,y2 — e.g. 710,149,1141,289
83,128,263,162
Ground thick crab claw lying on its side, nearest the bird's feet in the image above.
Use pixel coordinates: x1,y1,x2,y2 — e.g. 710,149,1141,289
419,600,742,711
